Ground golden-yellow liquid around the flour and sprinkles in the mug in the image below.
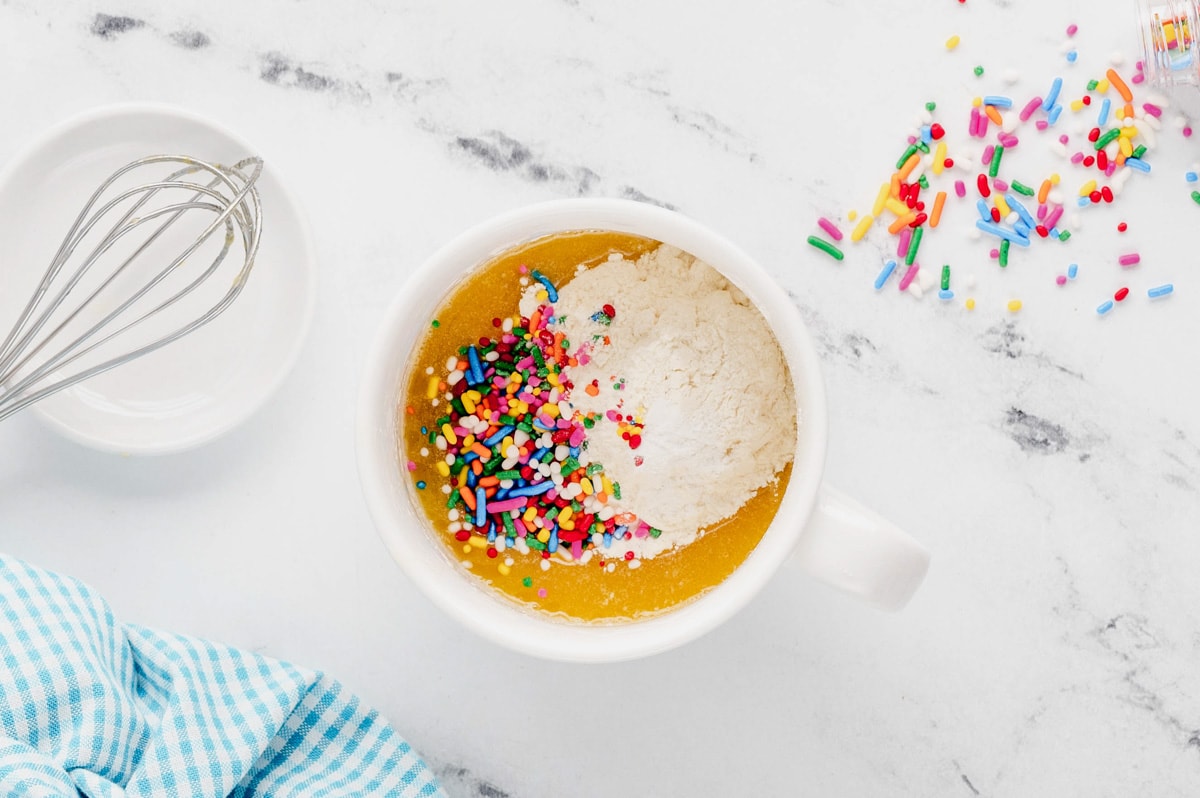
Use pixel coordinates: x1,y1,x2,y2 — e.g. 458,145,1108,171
398,230,791,622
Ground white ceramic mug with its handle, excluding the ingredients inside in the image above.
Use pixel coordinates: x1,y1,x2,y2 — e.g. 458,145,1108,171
358,199,929,662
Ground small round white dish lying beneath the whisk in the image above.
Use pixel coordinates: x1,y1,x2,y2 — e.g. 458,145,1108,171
0,104,317,455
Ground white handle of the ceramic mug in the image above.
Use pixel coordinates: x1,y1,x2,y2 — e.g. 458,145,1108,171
792,484,929,611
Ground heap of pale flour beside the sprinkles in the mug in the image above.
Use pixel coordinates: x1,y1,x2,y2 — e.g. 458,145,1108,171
522,246,798,558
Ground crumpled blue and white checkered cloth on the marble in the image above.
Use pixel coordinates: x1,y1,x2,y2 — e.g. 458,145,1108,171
0,556,444,798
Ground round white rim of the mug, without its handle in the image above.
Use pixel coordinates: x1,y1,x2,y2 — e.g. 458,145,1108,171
356,198,828,662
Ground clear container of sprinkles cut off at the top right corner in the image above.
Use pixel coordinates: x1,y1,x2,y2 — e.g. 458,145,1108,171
1138,0,1200,119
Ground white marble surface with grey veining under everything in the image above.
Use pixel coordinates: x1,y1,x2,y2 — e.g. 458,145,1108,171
0,0,1200,798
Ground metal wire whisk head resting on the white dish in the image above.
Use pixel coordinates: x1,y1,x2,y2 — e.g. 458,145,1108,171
0,155,263,421
